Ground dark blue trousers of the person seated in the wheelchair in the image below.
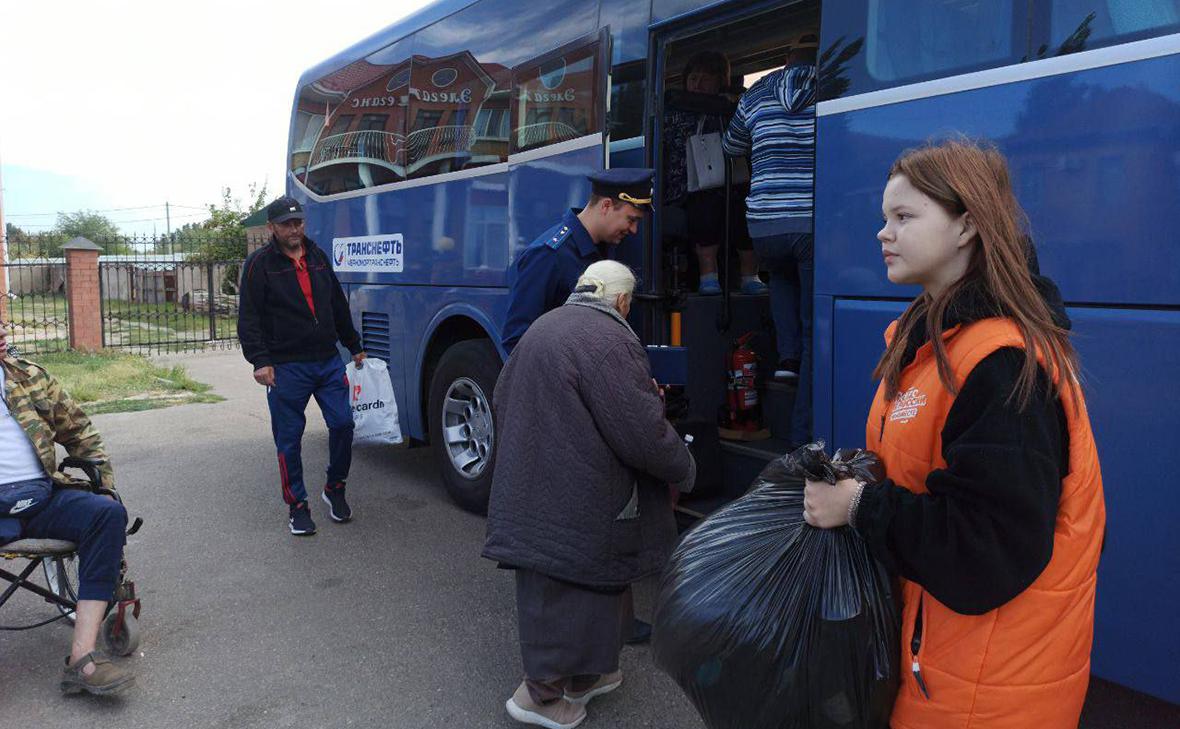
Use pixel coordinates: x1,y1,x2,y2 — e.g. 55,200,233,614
20,479,127,603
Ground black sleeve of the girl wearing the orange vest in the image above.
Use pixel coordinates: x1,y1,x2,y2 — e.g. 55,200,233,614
856,348,1069,615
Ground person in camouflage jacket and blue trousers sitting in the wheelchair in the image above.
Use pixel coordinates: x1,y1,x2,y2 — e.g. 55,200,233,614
0,322,135,694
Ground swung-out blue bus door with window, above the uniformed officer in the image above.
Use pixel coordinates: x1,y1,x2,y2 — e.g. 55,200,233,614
509,29,610,264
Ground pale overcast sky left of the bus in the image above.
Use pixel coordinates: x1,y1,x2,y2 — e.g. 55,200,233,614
0,0,428,234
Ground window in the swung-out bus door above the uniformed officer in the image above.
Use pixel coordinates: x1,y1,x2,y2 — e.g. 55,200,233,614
512,34,605,153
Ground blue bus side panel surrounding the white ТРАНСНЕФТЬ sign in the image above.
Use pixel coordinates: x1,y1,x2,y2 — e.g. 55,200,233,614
294,172,509,285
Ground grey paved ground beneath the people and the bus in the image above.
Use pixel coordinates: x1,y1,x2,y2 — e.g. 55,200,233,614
0,352,1180,729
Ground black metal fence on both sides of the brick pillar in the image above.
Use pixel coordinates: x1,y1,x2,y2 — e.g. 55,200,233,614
0,232,245,354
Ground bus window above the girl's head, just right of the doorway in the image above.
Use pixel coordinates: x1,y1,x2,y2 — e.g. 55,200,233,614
819,0,1029,100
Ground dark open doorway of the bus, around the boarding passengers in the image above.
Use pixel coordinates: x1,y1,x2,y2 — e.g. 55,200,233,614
643,0,819,517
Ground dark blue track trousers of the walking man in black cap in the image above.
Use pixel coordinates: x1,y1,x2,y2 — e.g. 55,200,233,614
267,357,353,505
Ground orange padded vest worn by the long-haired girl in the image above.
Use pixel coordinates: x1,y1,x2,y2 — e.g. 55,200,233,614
866,318,1106,729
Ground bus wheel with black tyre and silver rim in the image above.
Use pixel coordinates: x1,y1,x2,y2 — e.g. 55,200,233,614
427,340,500,514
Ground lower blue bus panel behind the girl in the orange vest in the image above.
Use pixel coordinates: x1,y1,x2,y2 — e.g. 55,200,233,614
832,293,1180,702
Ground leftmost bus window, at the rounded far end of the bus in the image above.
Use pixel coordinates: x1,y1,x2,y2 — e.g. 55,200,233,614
290,40,409,195
